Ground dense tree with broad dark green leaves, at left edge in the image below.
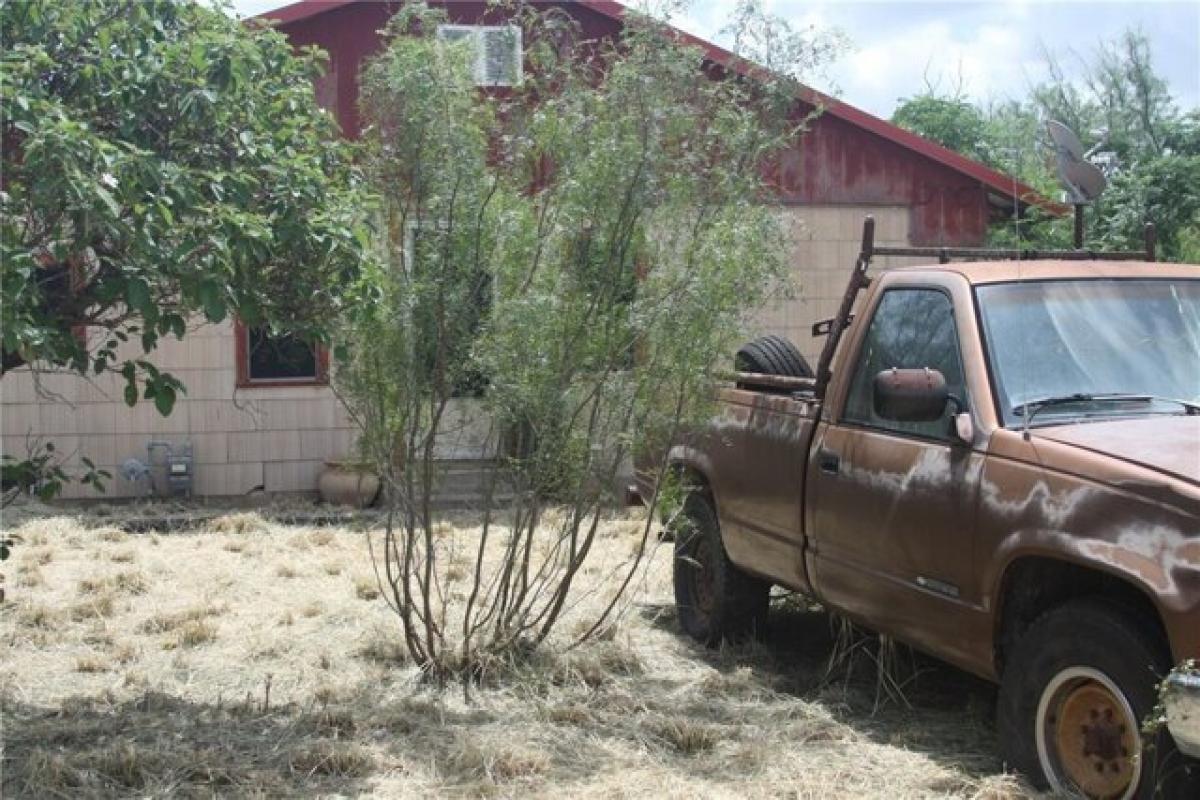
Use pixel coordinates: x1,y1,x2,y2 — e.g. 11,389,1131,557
0,0,361,414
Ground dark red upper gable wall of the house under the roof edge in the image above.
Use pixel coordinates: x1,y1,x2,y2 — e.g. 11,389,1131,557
282,0,989,246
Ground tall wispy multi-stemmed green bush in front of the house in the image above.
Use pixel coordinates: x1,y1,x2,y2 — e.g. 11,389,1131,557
335,4,825,675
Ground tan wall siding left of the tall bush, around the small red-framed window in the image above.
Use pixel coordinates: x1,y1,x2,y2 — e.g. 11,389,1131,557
0,320,355,498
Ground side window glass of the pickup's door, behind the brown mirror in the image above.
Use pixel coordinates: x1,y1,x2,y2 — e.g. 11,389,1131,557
842,289,966,439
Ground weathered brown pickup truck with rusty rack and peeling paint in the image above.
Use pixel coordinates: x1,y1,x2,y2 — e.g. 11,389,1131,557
641,215,1200,798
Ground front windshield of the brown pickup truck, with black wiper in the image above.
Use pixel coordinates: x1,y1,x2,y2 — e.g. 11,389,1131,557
976,278,1200,426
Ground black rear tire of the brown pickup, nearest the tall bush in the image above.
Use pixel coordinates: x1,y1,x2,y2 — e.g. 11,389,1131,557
674,493,770,646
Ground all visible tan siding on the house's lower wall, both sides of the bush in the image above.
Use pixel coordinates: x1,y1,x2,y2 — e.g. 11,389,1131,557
0,206,910,497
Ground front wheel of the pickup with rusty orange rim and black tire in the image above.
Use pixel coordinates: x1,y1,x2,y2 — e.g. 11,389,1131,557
996,597,1200,798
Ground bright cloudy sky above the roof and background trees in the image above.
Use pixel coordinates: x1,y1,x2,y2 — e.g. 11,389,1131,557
226,0,1200,118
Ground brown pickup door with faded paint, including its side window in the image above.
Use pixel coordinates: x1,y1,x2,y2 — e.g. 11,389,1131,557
805,287,983,658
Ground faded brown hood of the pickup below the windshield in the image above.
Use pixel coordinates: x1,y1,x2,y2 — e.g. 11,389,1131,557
1034,415,1200,486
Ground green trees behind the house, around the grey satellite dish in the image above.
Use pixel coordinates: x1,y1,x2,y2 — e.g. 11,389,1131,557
892,30,1200,263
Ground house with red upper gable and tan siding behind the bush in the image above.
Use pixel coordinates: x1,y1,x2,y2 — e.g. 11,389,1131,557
0,0,1043,497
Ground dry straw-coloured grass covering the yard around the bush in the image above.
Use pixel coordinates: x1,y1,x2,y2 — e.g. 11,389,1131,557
0,503,1022,800
